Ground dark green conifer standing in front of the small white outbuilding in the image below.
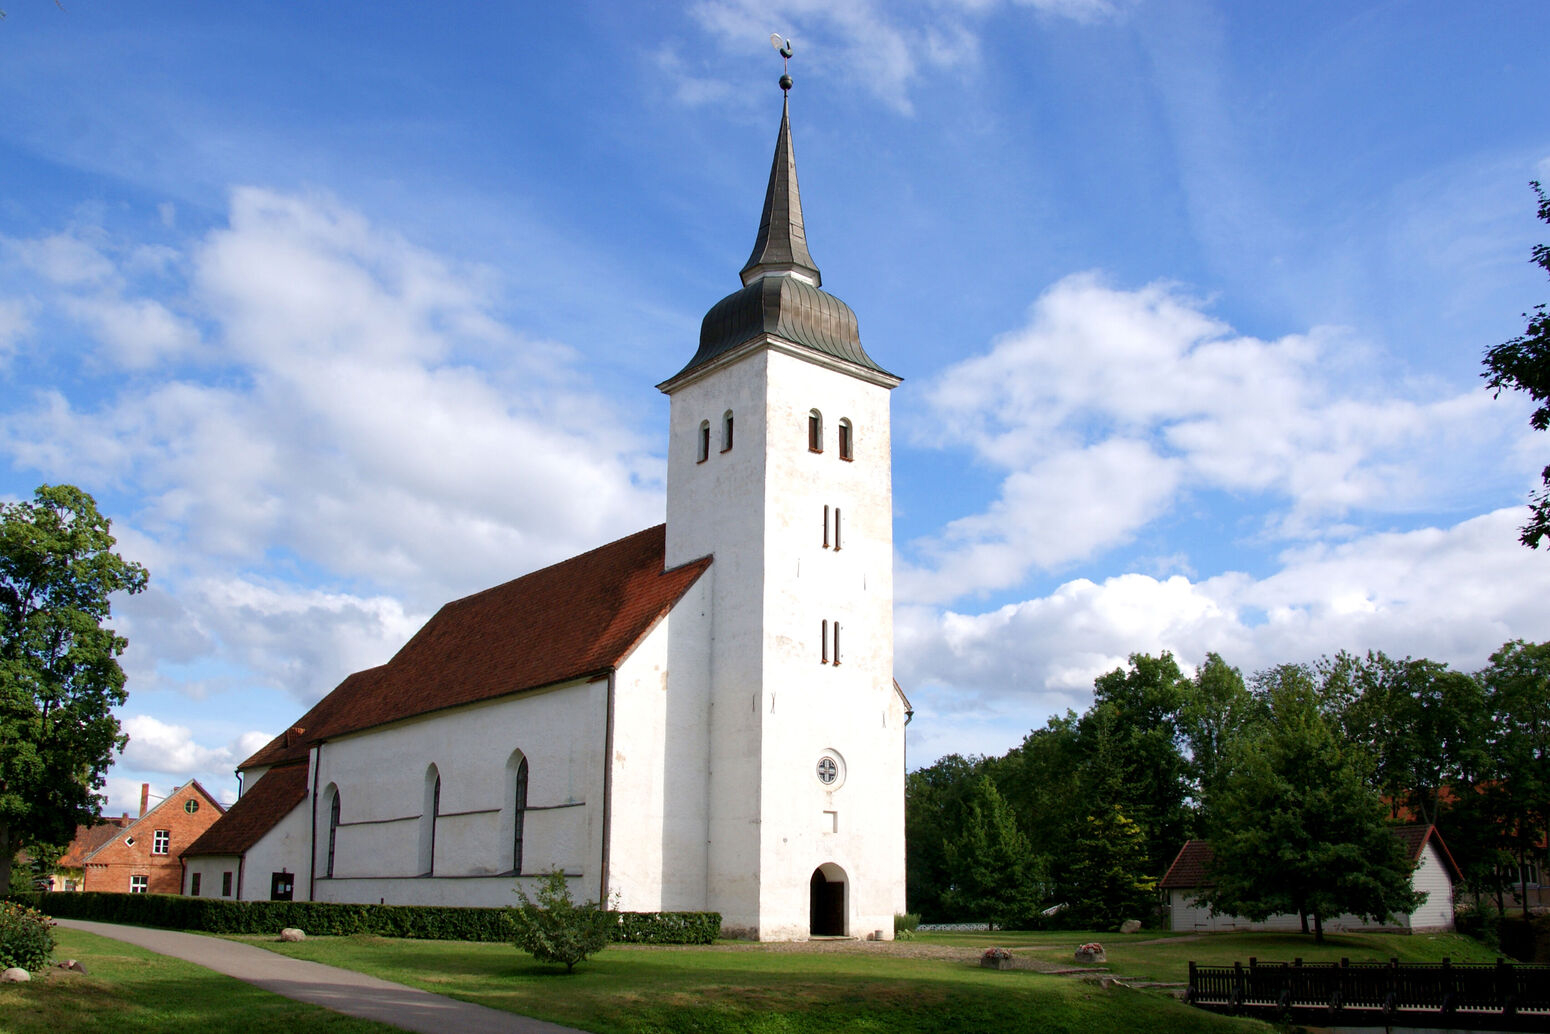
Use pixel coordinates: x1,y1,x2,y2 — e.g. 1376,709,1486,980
1203,665,1420,941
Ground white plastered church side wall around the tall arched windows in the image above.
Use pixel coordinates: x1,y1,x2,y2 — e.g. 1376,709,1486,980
308,679,608,907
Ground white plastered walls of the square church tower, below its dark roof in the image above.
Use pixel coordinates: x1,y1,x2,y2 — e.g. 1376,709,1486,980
668,337,905,939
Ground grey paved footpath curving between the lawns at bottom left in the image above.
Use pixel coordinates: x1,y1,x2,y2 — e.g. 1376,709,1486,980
54,919,581,1034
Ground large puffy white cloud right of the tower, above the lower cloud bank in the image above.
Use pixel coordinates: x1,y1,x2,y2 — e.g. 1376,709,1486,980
901,273,1535,601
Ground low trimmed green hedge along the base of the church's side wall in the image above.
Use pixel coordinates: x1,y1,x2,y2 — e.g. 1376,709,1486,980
8,891,721,944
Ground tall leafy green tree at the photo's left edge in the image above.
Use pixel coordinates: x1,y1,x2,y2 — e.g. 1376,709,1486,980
0,485,147,887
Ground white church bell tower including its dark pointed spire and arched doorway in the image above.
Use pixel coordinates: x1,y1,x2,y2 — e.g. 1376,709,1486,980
657,62,908,939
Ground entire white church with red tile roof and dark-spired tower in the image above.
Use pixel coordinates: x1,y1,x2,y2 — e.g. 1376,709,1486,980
183,78,911,939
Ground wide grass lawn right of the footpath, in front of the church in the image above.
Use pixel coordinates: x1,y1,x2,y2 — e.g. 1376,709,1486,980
226,936,1271,1034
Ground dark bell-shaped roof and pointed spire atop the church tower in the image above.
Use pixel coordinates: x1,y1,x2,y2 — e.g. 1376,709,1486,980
657,86,897,391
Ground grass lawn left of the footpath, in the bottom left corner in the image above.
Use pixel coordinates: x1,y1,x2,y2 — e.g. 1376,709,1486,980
0,929,397,1034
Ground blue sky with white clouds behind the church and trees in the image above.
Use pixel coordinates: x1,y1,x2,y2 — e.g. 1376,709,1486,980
0,0,1550,811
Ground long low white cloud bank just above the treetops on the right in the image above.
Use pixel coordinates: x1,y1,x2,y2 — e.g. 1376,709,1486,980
896,507,1550,750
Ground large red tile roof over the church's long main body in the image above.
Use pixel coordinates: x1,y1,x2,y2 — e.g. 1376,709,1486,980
242,524,710,767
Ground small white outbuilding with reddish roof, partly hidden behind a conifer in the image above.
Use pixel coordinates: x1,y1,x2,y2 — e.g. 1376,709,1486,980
1158,825,1460,933
